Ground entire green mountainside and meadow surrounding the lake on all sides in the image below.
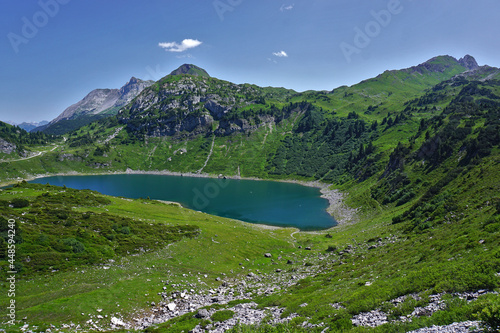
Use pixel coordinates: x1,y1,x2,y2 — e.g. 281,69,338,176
0,57,500,332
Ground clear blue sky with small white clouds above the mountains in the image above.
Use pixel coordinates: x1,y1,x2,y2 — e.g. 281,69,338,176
0,0,500,122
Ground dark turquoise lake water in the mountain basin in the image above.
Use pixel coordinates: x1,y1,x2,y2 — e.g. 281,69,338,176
31,175,336,230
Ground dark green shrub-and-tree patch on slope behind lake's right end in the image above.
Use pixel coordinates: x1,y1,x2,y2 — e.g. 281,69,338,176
267,108,377,182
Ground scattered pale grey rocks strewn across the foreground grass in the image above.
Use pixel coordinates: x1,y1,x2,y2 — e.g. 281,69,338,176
16,244,496,333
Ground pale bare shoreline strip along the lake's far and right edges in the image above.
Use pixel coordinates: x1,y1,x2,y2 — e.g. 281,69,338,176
0,169,358,228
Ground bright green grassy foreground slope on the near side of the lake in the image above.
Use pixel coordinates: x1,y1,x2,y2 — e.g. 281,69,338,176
0,163,500,332
